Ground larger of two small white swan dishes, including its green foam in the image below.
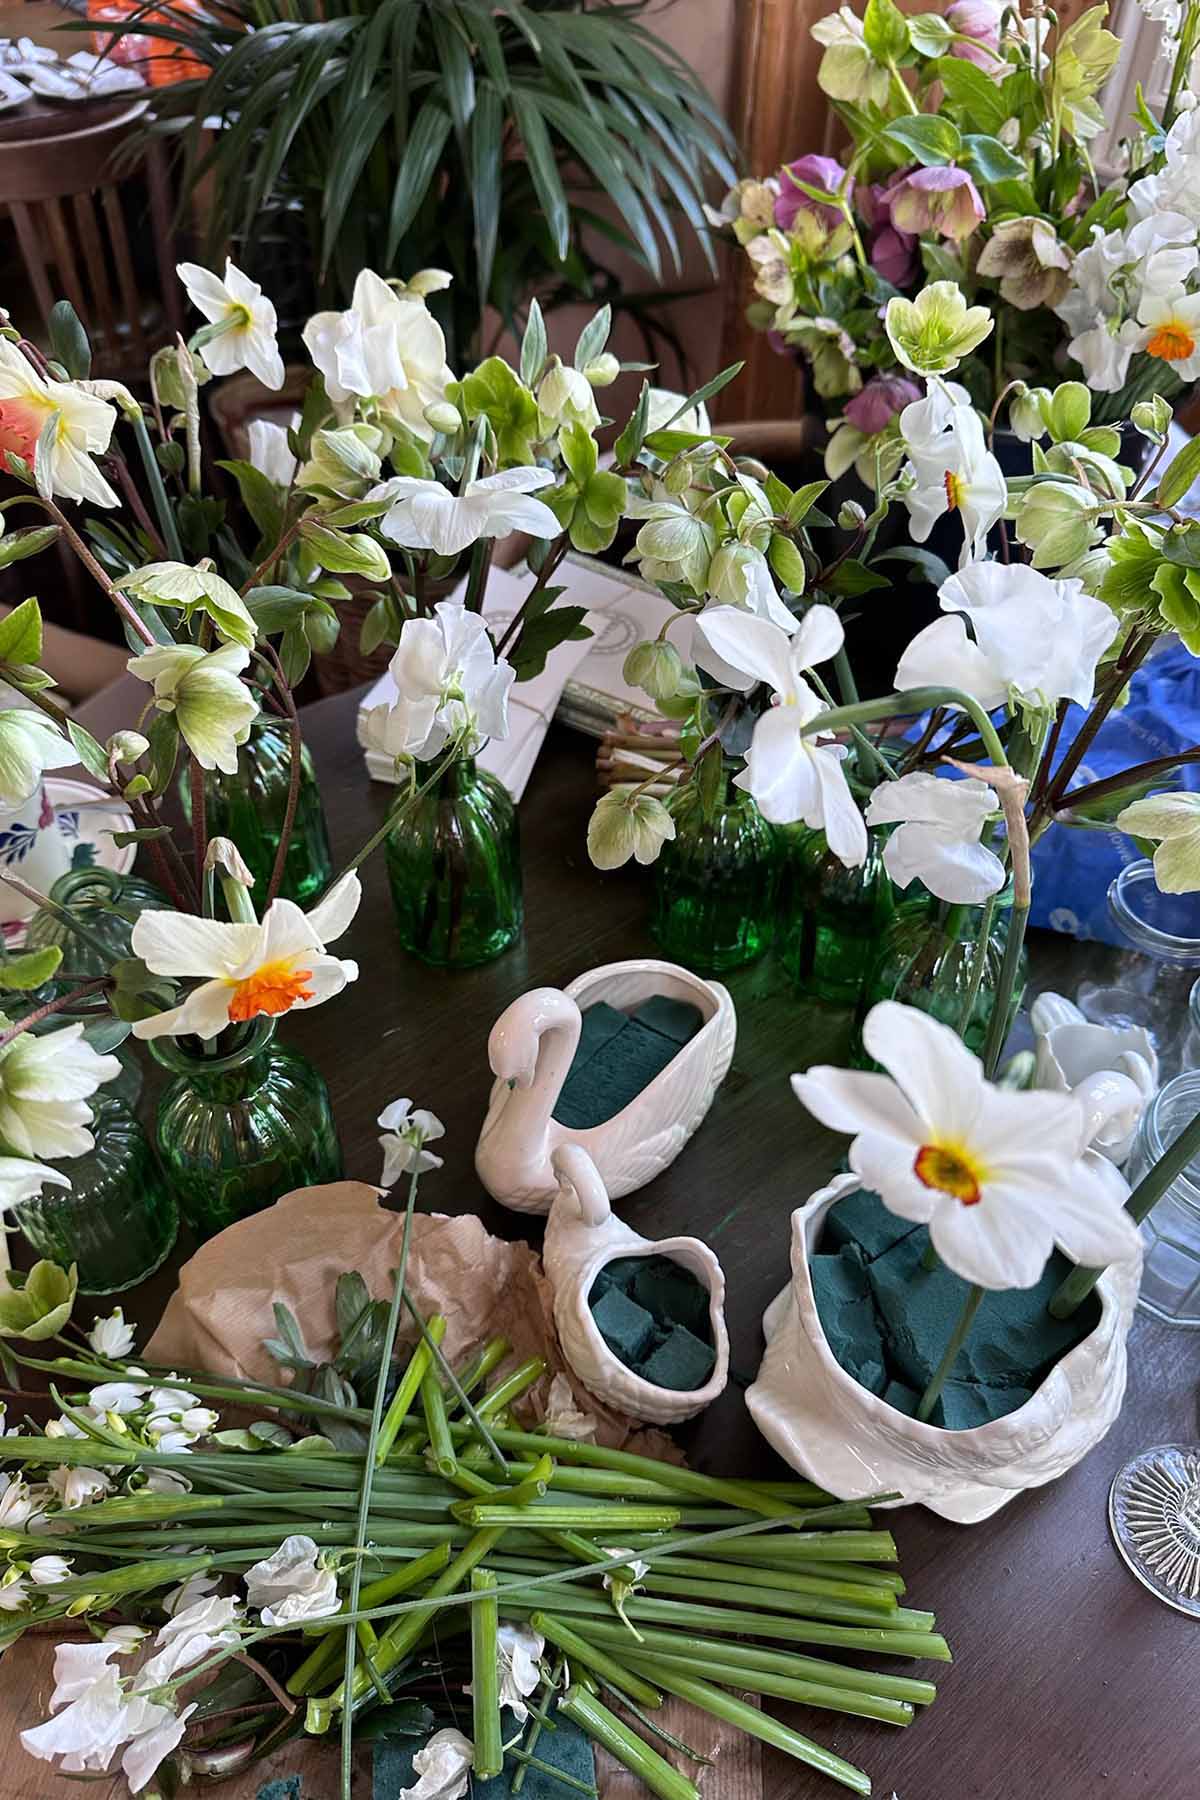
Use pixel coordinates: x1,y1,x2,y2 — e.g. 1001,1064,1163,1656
475,959,738,1213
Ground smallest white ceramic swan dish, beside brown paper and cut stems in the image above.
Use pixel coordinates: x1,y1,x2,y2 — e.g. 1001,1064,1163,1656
542,1143,729,1426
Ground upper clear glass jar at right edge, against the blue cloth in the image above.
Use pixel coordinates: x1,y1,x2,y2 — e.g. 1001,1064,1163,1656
1076,857,1200,1080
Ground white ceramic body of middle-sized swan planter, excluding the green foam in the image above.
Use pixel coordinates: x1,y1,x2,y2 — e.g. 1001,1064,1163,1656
475,959,738,1213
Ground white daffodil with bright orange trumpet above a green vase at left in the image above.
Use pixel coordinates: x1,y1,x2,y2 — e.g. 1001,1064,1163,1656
131,873,362,1039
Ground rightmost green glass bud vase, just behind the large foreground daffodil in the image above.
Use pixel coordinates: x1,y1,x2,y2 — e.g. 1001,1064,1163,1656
853,887,1029,1067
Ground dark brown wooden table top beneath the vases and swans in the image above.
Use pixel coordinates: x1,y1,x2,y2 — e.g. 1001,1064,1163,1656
0,695,1200,1800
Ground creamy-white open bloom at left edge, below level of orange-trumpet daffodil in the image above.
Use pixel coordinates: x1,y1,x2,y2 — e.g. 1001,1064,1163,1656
0,1015,121,1156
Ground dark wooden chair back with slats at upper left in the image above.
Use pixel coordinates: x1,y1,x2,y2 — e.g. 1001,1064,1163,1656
0,99,184,385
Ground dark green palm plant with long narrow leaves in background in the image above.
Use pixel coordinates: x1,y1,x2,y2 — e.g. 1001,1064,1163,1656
122,0,732,364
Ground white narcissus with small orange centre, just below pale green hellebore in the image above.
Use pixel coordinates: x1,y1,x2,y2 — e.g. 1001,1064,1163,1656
900,389,1007,565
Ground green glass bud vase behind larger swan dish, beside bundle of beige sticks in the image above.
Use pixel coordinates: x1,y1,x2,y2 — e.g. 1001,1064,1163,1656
649,745,781,972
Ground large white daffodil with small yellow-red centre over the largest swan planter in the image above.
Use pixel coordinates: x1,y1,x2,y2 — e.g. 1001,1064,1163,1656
792,1001,1139,1287
